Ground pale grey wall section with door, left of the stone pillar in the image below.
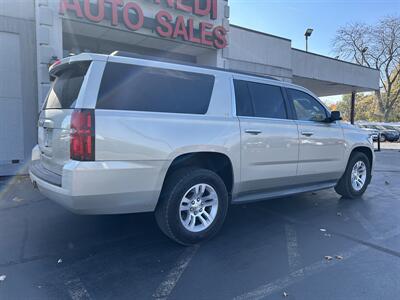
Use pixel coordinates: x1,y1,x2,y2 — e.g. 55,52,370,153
0,4,37,176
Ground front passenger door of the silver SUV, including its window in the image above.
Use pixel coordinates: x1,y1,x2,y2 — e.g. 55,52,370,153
287,88,346,180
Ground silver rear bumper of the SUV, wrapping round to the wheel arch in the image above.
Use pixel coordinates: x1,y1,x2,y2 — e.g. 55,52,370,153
29,160,165,214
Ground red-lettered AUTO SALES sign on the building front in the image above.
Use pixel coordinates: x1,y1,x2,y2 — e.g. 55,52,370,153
60,0,227,49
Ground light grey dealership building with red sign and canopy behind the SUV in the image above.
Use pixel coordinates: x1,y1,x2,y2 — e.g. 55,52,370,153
0,0,379,176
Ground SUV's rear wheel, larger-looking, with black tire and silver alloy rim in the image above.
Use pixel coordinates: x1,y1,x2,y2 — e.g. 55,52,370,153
155,168,228,245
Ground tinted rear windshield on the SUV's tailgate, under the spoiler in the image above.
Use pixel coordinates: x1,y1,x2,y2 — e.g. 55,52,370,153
44,61,90,109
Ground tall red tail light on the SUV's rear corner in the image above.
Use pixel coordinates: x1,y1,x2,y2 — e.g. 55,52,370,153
70,109,95,161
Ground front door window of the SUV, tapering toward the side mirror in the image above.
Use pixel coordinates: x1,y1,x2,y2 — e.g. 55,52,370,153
287,89,327,122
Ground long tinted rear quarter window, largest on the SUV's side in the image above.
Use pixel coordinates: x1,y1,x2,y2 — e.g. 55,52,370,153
96,63,214,114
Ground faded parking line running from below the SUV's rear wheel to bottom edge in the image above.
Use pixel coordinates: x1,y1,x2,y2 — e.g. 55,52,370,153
153,245,199,300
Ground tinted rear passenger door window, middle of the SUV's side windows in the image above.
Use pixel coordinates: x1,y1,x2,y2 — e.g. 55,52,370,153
235,80,287,119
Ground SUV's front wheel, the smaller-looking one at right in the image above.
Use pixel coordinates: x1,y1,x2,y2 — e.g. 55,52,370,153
335,152,371,199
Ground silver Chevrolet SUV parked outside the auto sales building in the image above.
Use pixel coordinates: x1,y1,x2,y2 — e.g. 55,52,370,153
30,52,374,245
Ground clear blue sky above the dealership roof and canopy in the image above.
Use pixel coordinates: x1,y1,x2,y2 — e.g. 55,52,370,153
229,0,400,104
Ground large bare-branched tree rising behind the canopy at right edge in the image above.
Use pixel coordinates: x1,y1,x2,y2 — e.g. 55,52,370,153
333,16,400,121
